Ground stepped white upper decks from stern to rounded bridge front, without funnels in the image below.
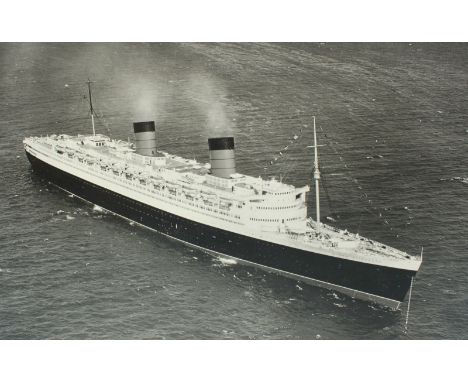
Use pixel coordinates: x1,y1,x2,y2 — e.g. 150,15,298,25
25,134,309,228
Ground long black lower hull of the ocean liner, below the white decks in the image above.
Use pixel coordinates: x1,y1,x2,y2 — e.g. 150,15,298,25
26,152,416,308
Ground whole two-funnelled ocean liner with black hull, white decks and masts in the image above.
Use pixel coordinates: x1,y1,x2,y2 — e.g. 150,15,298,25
23,81,422,309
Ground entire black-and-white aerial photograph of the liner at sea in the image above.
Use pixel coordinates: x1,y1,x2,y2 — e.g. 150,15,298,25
0,0,468,379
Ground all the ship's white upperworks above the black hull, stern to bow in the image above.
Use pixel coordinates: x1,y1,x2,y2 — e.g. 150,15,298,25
24,134,421,270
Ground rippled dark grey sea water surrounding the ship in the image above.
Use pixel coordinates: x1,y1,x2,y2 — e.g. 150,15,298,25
0,43,468,339
